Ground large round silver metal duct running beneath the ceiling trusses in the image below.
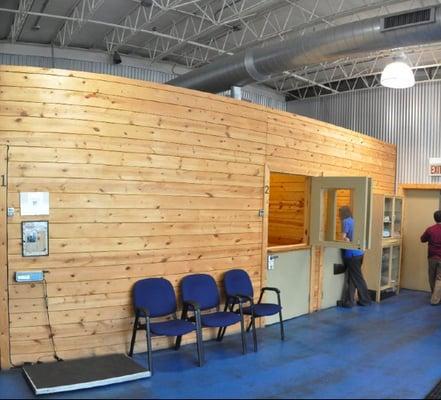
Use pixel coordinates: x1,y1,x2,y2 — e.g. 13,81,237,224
167,6,441,93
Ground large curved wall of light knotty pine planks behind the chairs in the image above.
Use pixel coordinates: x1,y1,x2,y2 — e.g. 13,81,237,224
0,66,395,364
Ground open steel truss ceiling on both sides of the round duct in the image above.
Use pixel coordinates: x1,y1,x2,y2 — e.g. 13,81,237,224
0,0,441,99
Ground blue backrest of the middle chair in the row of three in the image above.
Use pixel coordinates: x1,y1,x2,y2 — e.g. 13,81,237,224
181,274,220,310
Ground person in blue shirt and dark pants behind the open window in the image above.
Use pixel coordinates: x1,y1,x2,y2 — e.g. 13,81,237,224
338,206,371,307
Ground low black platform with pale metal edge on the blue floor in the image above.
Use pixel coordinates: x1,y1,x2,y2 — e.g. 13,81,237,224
23,354,151,395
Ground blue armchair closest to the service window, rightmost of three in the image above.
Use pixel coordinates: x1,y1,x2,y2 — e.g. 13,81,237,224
221,269,285,351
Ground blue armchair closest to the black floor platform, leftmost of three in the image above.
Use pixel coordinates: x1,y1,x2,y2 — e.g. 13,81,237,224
129,278,204,373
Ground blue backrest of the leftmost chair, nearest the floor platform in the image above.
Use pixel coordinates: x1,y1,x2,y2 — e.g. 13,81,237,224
133,278,176,317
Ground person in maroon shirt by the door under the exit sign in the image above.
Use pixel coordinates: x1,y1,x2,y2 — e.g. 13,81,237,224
421,210,441,305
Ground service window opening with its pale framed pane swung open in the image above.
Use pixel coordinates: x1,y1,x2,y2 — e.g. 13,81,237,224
267,172,372,252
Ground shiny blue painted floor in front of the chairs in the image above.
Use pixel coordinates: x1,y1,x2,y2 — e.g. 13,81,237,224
0,291,441,399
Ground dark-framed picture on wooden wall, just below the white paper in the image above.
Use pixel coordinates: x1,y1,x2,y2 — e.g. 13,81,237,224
21,221,49,257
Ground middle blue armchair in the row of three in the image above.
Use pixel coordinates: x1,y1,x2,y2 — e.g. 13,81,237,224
178,274,246,354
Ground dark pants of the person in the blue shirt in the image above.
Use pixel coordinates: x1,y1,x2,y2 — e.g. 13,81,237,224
342,256,371,306
